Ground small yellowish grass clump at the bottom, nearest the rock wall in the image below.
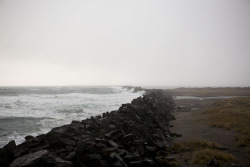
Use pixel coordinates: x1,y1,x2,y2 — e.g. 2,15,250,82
171,140,236,165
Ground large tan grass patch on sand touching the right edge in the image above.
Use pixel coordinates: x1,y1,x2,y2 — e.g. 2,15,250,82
204,97,250,147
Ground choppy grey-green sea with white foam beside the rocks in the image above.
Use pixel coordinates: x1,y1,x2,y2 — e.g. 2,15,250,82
0,87,144,147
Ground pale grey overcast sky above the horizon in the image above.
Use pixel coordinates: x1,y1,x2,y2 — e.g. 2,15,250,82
0,0,250,86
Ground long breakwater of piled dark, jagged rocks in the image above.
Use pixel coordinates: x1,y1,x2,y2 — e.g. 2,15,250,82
0,90,174,167
